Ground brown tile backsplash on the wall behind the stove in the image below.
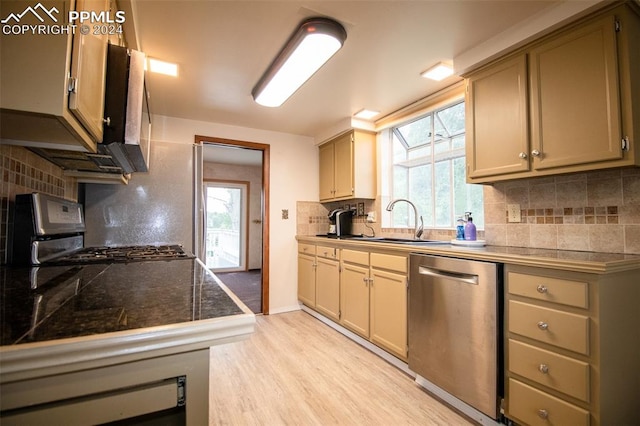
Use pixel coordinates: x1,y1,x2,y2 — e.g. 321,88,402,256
0,142,78,264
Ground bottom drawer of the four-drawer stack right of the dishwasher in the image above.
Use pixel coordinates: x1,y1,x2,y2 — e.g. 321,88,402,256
507,379,589,426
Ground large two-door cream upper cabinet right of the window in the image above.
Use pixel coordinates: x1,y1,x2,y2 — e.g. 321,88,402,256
465,5,640,183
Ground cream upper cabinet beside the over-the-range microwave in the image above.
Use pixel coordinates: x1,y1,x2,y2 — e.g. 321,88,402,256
0,0,109,152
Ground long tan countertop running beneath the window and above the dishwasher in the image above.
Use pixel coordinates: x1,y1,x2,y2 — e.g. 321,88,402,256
296,235,640,274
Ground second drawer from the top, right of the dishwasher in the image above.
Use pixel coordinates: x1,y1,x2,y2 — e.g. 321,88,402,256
508,300,589,355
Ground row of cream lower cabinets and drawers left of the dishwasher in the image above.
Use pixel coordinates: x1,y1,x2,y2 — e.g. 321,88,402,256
298,243,408,361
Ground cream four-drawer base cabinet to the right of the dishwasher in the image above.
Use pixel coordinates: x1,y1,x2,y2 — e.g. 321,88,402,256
505,265,640,425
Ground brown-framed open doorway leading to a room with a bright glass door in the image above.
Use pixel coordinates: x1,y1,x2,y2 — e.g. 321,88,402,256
195,136,269,315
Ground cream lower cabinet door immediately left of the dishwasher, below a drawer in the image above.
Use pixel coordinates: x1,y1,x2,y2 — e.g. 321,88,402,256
370,268,407,359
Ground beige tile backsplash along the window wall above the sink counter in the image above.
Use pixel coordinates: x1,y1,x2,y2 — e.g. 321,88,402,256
297,168,640,254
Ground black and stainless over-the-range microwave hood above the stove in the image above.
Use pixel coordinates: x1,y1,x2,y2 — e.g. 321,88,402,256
27,44,151,183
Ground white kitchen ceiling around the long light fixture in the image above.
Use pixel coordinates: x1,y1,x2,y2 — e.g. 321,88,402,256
132,0,593,137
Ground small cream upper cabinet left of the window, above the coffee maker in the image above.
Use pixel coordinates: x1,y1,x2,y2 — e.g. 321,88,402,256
319,130,376,202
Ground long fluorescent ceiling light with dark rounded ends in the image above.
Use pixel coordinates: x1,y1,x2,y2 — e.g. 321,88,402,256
251,18,347,107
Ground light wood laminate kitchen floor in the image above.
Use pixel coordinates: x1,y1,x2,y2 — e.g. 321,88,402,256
209,311,472,426
